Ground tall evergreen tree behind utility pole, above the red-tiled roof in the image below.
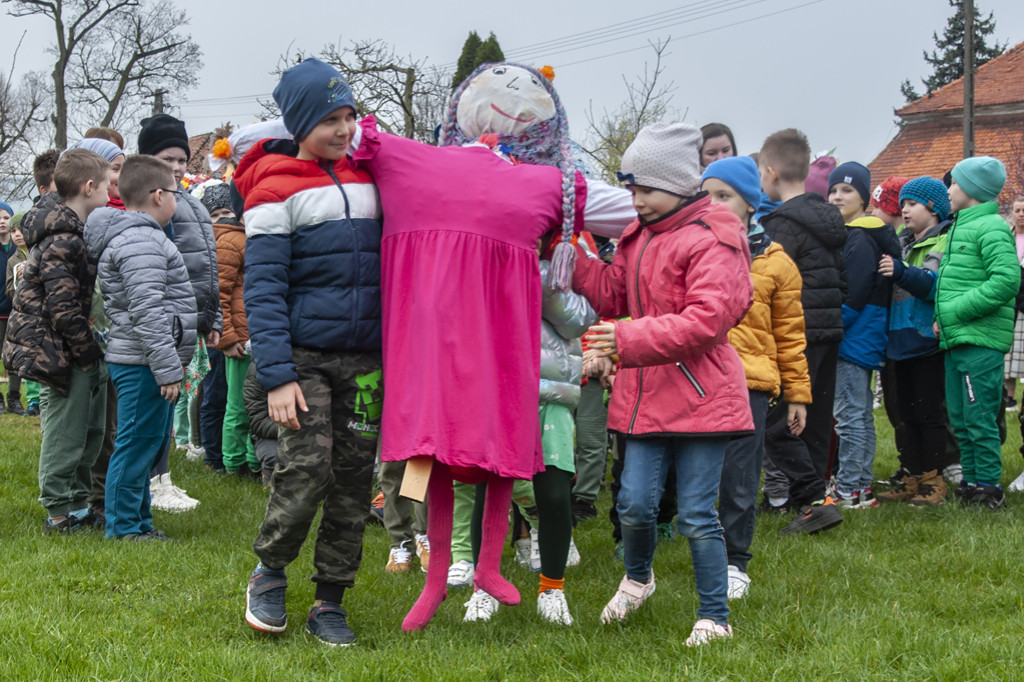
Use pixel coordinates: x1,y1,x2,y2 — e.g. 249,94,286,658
900,0,1007,101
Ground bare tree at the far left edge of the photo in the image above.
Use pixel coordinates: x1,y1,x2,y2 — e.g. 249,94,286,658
0,34,50,200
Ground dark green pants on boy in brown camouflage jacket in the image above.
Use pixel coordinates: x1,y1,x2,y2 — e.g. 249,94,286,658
39,360,106,517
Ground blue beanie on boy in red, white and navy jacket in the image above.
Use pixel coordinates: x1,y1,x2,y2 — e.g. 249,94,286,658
273,58,355,142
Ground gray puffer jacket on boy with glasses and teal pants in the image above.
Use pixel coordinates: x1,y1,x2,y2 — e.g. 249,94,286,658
85,208,197,386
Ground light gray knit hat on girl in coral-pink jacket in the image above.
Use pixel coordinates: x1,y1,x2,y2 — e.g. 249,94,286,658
618,122,703,197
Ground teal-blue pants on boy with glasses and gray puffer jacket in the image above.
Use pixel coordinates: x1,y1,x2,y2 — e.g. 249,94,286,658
105,363,174,538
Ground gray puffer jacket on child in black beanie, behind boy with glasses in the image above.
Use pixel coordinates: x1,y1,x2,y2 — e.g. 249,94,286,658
171,191,223,336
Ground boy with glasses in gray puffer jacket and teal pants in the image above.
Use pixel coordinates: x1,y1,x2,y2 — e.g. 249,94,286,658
85,156,197,541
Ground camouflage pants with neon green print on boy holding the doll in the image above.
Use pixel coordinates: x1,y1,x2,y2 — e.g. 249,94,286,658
253,348,383,587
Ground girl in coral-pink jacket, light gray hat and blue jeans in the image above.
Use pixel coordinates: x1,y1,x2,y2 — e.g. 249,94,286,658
572,123,754,646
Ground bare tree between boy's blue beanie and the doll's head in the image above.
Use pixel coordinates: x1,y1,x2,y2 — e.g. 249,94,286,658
270,39,450,142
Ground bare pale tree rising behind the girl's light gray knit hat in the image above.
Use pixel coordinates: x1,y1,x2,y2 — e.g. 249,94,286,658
581,38,676,182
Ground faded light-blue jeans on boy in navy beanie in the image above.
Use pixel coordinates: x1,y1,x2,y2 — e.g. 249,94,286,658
835,358,874,496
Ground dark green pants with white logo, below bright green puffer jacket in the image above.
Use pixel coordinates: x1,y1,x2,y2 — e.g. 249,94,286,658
945,345,1004,485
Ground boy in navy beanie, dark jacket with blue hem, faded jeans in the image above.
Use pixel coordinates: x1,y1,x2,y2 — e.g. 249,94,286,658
828,161,901,509
